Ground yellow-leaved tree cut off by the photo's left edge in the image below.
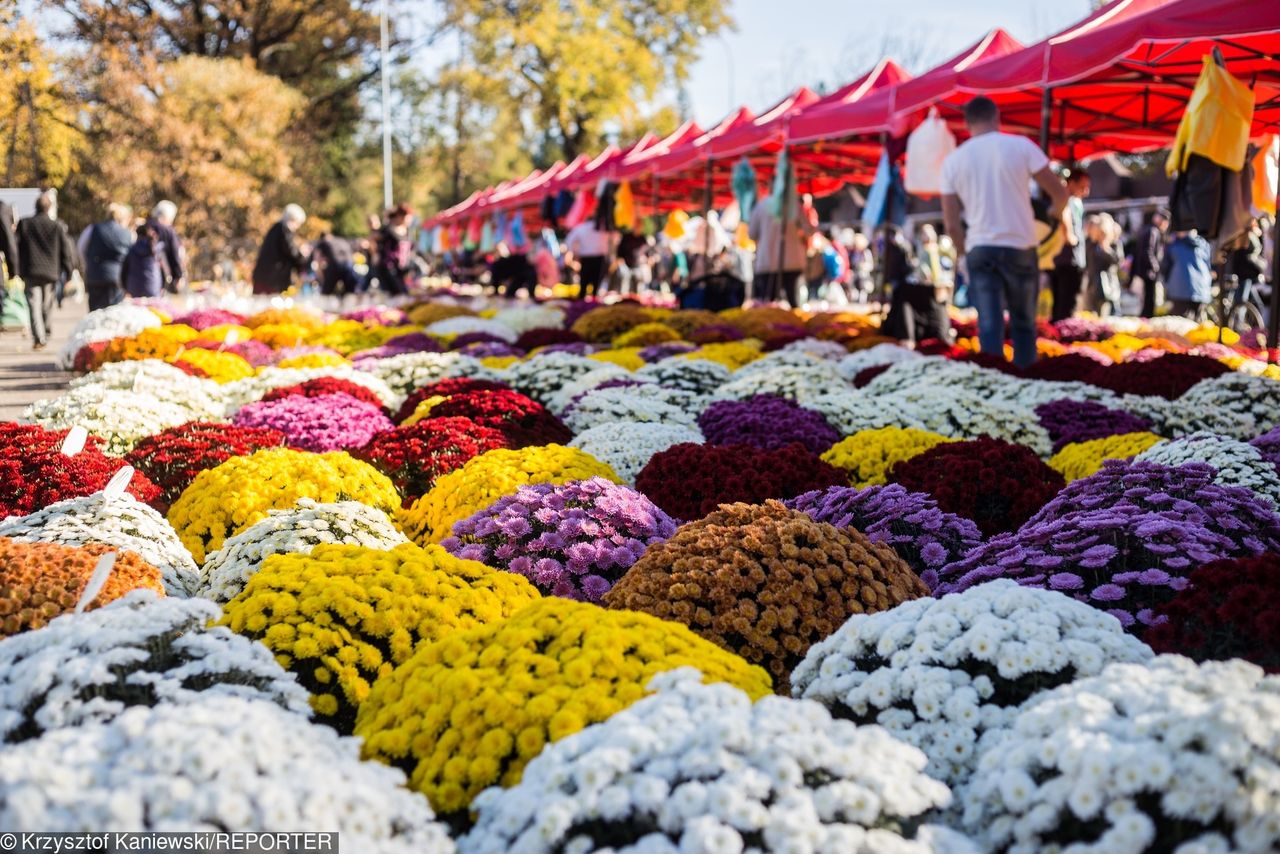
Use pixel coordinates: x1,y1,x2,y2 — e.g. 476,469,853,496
0,15,81,187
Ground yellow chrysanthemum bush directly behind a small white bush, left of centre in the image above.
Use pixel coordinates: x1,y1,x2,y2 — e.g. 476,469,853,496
169,448,401,563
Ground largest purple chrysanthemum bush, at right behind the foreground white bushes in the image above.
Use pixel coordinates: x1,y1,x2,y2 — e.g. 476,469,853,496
922,461,1280,629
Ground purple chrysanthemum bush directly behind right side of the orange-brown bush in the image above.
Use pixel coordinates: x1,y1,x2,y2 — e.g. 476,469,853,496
786,484,982,572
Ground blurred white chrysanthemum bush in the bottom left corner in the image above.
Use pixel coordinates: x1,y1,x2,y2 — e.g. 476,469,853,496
0,697,453,854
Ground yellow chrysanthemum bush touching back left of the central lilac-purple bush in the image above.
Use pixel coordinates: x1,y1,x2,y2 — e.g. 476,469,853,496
399,444,622,545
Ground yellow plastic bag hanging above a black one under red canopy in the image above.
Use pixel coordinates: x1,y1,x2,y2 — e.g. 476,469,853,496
1165,55,1253,177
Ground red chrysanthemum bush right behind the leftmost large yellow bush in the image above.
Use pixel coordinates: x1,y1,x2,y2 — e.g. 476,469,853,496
125,421,284,512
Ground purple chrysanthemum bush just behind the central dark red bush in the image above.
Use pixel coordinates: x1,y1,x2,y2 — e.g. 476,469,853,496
698,394,840,453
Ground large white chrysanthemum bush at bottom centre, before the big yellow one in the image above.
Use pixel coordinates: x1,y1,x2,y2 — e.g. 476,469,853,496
460,667,950,854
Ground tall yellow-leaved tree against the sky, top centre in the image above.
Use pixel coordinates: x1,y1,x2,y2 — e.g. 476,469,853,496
443,0,730,159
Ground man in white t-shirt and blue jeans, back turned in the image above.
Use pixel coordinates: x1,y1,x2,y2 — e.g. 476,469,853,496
941,95,1068,367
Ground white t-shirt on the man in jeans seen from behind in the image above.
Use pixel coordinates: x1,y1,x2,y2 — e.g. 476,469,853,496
941,133,1048,250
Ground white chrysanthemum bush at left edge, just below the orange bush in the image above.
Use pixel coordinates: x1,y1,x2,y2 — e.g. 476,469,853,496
0,590,310,743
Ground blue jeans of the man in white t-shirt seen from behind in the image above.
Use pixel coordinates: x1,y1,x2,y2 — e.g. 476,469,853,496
968,246,1039,367
